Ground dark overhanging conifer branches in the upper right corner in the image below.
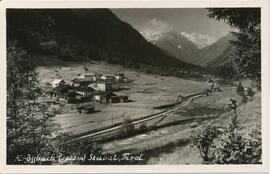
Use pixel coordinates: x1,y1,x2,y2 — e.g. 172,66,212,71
208,8,261,84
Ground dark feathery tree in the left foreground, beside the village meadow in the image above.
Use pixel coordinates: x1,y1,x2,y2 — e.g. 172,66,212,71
7,42,60,164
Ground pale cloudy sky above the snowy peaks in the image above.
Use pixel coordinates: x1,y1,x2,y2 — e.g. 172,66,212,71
111,8,232,40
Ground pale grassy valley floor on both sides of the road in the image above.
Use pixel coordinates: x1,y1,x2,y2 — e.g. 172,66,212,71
37,58,261,164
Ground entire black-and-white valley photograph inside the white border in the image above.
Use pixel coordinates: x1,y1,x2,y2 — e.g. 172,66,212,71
1,0,265,172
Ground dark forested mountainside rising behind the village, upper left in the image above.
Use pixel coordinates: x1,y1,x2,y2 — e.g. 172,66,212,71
7,9,194,68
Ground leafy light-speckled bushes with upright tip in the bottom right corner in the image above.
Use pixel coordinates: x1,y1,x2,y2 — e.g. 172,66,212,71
194,99,262,164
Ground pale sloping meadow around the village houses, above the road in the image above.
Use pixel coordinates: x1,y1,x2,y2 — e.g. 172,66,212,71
34,59,210,133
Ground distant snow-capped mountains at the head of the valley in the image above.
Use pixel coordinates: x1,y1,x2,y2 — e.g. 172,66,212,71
141,30,234,68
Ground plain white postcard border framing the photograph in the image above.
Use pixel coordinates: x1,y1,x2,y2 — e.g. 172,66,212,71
0,0,269,173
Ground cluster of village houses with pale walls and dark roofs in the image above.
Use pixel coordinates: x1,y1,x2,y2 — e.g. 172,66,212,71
47,73,128,113
